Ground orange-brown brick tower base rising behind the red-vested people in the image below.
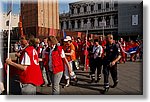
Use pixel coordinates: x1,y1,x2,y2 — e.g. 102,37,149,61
21,0,59,36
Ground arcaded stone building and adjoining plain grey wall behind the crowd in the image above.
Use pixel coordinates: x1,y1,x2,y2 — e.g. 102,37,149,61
60,0,143,37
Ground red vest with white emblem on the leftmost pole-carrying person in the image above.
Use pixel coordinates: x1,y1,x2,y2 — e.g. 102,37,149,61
19,46,44,86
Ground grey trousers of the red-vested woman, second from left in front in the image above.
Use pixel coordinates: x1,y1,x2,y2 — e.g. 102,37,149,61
52,72,63,95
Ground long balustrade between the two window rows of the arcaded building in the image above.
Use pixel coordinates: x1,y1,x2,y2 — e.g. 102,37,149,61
70,8,118,17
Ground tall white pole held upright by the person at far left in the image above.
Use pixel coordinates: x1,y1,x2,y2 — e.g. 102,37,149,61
7,0,13,95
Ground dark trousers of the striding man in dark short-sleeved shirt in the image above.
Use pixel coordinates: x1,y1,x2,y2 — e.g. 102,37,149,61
103,61,118,88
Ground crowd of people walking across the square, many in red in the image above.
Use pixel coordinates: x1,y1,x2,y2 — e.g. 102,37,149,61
0,34,143,95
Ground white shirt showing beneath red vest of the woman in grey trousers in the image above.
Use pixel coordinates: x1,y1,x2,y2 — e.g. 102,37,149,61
48,46,66,71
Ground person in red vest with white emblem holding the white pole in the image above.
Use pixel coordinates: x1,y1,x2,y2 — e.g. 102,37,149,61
6,37,43,95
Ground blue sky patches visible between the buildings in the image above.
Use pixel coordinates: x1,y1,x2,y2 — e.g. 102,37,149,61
1,0,81,14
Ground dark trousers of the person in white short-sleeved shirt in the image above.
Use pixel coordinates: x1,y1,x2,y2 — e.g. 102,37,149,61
91,57,103,79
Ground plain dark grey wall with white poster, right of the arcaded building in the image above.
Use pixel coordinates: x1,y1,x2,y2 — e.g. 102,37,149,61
118,2,143,36
